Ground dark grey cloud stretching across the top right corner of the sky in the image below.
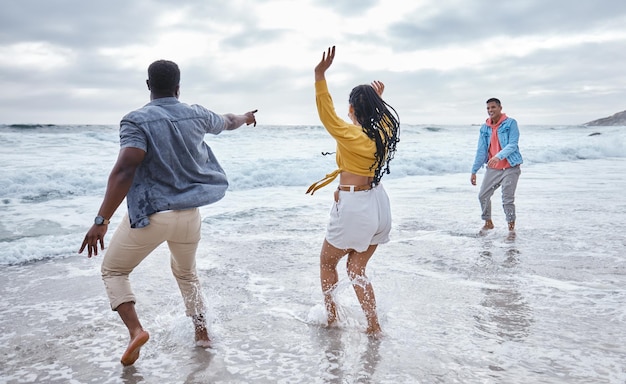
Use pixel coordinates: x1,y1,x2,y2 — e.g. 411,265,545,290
387,0,626,51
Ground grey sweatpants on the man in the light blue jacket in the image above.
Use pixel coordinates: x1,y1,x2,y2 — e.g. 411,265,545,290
478,165,522,223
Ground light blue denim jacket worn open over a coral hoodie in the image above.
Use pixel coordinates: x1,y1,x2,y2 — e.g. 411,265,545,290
472,117,523,174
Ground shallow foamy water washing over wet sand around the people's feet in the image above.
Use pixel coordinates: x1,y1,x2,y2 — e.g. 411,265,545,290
0,160,626,383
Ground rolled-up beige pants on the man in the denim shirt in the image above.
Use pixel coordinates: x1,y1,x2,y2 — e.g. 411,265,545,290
101,208,205,316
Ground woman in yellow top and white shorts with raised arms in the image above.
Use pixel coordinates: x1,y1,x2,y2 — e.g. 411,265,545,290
307,46,400,337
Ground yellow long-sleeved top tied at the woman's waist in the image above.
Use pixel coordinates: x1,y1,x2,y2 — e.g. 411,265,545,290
306,80,376,194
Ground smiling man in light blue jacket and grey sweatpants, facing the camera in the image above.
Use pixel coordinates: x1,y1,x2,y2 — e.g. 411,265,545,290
470,98,523,239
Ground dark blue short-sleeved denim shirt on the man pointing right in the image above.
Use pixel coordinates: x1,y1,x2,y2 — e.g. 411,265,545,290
120,97,228,228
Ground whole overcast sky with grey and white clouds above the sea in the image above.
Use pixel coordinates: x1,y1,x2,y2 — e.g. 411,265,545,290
0,0,626,125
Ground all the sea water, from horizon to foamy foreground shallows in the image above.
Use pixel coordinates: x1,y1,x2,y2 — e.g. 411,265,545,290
0,122,626,383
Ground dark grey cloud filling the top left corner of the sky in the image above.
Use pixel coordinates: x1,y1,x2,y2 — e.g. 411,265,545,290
0,0,252,50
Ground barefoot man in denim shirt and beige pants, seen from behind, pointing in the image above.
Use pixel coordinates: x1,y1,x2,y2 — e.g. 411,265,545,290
79,60,257,365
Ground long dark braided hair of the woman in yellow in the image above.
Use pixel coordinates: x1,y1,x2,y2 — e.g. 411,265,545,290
349,84,400,185
